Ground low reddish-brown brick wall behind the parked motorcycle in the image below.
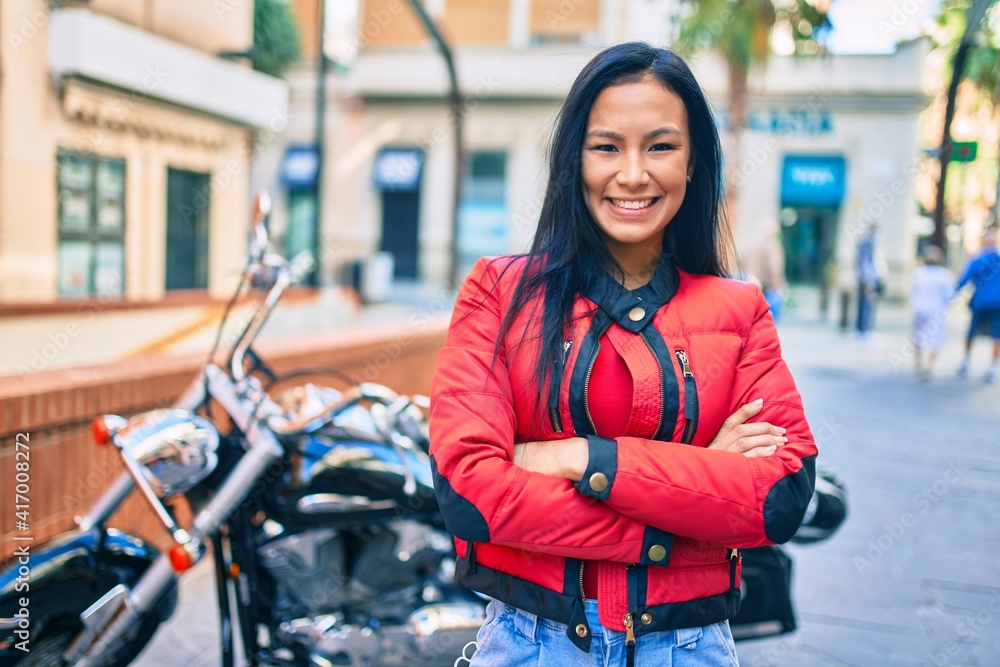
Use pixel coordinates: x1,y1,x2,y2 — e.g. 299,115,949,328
0,318,447,560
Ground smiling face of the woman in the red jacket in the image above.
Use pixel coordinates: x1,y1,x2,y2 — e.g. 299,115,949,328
583,76,691,261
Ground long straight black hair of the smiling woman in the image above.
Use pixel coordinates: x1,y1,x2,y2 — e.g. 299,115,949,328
498,42,728,408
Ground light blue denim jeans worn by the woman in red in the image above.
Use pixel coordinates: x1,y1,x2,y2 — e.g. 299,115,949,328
461,600,739,667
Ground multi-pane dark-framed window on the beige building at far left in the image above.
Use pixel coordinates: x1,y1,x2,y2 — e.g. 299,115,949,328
57,150,125,297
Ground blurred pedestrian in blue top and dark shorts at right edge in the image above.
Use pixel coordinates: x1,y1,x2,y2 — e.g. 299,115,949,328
955,227,1000,382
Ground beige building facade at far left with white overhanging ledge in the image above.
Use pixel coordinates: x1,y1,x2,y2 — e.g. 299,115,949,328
0,0,288,304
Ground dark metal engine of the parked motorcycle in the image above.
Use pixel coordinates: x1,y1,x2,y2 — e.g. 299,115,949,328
258,520,451,614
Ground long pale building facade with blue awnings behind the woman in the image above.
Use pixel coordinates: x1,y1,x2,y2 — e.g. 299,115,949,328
254,0,929,294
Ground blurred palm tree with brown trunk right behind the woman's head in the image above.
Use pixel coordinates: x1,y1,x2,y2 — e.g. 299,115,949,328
676,0,830,226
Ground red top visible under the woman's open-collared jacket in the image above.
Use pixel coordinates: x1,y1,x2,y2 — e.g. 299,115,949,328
583,335,633,600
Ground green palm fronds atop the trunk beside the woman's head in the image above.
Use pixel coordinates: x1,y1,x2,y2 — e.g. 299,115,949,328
674,0,830,69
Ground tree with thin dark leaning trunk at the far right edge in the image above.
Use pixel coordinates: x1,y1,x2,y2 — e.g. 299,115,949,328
933,0,1000,235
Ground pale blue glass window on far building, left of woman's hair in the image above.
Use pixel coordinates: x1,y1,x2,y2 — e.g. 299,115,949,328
458,151,510,273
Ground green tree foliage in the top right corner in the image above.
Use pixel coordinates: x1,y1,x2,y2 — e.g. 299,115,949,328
934,0,1000,105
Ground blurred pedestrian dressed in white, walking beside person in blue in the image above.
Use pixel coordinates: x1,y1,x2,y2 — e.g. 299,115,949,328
910,245,955,380
